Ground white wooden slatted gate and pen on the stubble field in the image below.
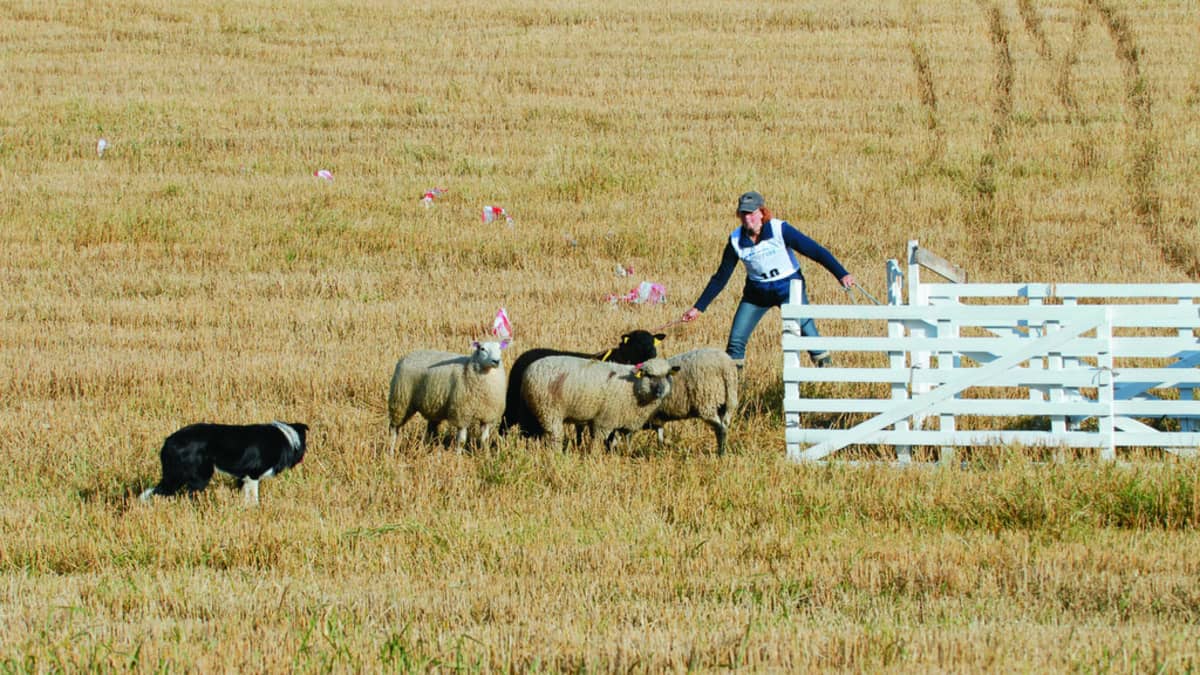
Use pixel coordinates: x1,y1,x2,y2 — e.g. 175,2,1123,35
782,243,1200,462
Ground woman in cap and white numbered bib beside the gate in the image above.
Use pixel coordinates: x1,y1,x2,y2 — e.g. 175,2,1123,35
682,191,854,369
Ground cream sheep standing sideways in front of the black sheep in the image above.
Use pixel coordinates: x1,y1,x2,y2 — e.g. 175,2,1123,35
521,357,679,449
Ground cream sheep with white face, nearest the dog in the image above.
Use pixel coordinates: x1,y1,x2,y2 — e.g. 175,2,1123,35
388,340,509,454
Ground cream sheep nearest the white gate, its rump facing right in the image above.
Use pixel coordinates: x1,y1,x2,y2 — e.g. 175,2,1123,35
650,348,738,455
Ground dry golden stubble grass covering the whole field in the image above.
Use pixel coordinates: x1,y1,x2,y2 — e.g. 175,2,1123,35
0,0,1200,671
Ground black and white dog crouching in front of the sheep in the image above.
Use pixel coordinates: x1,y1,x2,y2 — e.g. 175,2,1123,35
142,422,308,504
